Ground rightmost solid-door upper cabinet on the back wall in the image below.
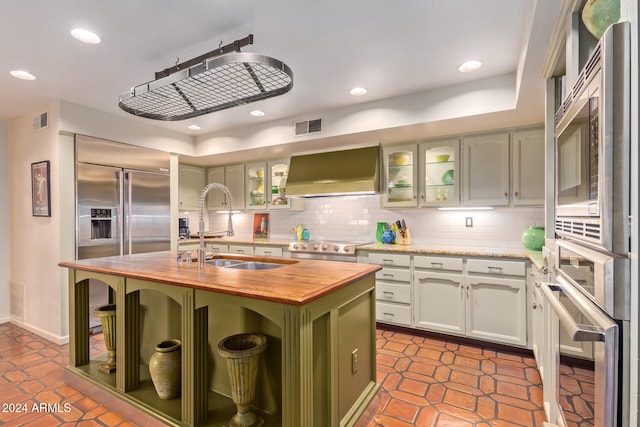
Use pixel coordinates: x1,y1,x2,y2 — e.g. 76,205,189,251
511,128,545,206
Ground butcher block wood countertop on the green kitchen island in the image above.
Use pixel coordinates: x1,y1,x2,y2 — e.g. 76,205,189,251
59,251,381,306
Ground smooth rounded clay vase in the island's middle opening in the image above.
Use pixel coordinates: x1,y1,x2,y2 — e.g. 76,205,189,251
149,340,182,400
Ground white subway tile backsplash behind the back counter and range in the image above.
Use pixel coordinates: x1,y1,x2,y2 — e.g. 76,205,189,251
182,196,544,251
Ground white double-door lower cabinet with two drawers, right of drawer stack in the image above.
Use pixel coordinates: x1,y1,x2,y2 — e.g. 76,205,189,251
413,256,528,347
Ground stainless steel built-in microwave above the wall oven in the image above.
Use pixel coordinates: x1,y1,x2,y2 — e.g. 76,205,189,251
555,22,630,253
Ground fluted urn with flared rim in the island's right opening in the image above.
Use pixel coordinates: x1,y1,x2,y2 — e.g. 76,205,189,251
218,334,267,427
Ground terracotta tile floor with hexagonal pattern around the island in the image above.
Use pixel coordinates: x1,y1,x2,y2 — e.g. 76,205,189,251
0,323,544,427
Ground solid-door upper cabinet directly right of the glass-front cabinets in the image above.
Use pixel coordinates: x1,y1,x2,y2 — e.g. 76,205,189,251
462,132,509,206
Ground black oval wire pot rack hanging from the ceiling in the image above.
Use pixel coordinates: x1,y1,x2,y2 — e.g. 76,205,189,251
118,34,293,121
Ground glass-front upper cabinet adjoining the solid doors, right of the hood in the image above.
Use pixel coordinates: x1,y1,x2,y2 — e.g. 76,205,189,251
419,139,460,207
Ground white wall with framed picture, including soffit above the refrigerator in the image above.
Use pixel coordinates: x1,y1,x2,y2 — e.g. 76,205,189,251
6,101,193,343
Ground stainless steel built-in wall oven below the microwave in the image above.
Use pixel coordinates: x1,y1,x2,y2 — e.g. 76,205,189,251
539,239,629,427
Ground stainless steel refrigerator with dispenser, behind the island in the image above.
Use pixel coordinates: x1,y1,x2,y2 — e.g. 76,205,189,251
76,136,171,328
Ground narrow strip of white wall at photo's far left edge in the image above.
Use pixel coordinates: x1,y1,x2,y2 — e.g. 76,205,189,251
0,121,11,323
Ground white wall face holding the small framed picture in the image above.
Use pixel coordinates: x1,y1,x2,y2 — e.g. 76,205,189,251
9,104,67,343
